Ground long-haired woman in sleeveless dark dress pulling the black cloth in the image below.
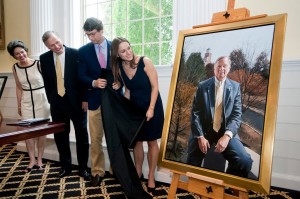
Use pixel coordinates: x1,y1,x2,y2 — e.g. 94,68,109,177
111,37,164,191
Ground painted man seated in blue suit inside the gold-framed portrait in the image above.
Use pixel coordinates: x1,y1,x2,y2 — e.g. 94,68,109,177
187,56,253,177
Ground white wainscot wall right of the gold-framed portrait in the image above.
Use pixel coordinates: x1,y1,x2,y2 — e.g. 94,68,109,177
271,60,300,190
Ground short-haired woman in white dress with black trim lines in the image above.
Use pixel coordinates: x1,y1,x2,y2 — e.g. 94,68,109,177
7,40,50,172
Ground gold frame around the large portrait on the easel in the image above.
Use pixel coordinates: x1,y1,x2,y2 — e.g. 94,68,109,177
158,13,287,193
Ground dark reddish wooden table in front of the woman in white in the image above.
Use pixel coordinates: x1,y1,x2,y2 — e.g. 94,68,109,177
0,118,65,146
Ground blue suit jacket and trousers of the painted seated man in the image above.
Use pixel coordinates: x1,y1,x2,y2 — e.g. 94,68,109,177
187,77,252,177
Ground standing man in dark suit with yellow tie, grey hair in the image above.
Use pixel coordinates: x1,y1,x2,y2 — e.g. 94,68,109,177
40,31,90,180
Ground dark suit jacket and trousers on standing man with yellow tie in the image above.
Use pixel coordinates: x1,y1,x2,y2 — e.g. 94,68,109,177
40,47,89,170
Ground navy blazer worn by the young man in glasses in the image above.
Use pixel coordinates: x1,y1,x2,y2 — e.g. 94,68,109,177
78,40,111,110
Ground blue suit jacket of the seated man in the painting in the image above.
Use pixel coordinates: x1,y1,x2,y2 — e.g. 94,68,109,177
191,77,242,137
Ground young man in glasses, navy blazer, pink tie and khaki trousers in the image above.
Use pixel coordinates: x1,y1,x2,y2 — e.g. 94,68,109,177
78,17,113,186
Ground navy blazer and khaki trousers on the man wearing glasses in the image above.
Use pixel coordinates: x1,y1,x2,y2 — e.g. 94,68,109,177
78,40,113,177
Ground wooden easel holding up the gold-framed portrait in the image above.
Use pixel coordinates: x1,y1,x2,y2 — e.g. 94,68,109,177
168,0,267,199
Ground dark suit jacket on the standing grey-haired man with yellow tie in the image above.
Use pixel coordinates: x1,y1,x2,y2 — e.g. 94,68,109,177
40,46,84,111
